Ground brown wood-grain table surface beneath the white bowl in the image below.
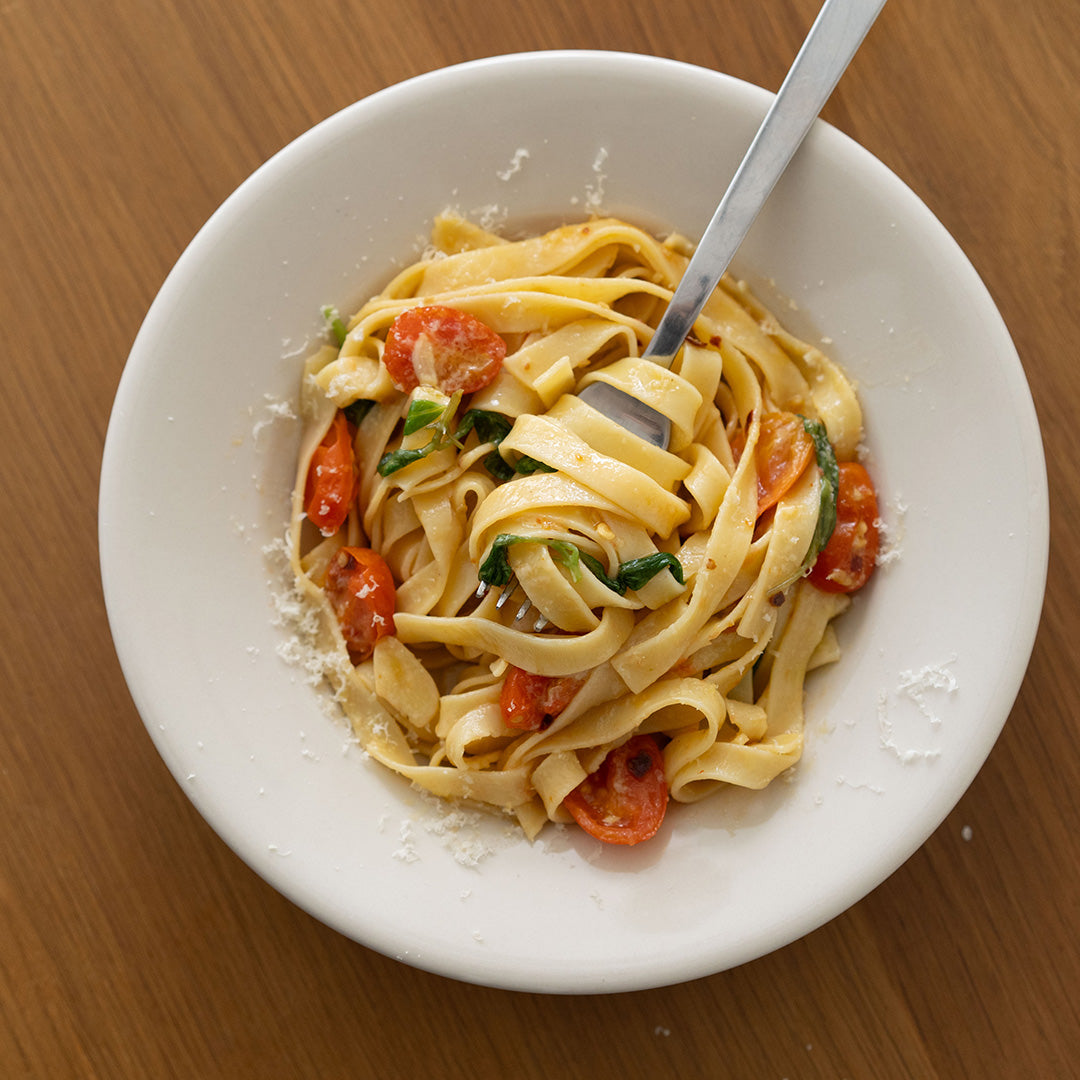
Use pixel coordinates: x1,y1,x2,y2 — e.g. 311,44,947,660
0,0,1080,1080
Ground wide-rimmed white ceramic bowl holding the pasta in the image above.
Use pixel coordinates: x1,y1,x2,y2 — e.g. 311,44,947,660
100,53,1048,993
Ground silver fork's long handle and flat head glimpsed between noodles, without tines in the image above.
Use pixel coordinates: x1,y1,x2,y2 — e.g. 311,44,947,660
579,0,886,449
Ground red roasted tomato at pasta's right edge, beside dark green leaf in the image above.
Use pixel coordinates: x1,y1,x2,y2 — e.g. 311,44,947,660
809,461,880,593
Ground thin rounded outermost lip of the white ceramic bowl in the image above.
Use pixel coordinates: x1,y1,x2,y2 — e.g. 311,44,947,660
98,50,1050,993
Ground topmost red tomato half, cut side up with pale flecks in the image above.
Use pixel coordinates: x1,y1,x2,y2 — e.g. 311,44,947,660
382,305,507,394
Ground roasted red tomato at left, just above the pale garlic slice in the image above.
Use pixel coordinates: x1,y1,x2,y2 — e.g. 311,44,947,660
325,548,395,664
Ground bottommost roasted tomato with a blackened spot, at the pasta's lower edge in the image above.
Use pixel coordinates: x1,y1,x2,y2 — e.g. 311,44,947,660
563,735,667,843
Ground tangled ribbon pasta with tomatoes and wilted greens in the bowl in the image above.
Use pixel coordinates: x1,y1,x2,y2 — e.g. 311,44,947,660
288,214,878,843
